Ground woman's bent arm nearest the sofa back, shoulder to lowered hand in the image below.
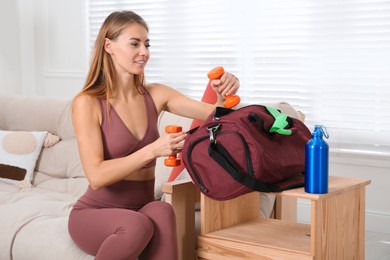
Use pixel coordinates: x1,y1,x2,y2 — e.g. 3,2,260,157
72,95,185,189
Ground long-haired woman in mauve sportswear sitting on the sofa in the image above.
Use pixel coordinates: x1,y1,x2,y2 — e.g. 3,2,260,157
69,11,239,260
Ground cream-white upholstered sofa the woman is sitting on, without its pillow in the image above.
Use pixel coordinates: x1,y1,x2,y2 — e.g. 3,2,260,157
0,95,301,260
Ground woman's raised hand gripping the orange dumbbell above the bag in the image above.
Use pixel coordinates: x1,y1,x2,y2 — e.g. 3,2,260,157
210,71,240,101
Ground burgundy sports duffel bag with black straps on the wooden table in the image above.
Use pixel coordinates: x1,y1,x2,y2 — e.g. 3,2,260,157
182,105,311,200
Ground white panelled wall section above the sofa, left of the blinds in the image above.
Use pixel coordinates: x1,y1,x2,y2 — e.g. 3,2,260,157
0,0,87,98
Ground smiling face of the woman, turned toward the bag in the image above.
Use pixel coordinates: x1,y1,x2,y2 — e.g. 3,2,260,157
104,23,150,74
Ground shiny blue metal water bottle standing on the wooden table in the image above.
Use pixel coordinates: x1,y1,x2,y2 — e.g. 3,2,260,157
305,125,329,194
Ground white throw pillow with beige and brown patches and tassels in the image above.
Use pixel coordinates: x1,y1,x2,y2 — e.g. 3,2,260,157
0,130,47,188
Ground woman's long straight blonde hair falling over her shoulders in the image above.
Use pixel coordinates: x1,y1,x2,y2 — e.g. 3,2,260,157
79,11,149,101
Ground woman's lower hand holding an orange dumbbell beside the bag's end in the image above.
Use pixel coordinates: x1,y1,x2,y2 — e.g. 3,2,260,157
152,132,187,158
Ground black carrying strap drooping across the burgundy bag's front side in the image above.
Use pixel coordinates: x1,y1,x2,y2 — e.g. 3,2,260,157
208,136,280,192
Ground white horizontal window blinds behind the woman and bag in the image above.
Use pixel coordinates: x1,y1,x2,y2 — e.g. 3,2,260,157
87,0,390,160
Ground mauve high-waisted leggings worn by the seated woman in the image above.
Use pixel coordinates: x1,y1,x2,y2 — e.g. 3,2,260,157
68,181,178,260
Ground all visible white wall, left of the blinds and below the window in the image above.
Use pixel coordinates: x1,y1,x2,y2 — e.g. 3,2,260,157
0,0,390,234
